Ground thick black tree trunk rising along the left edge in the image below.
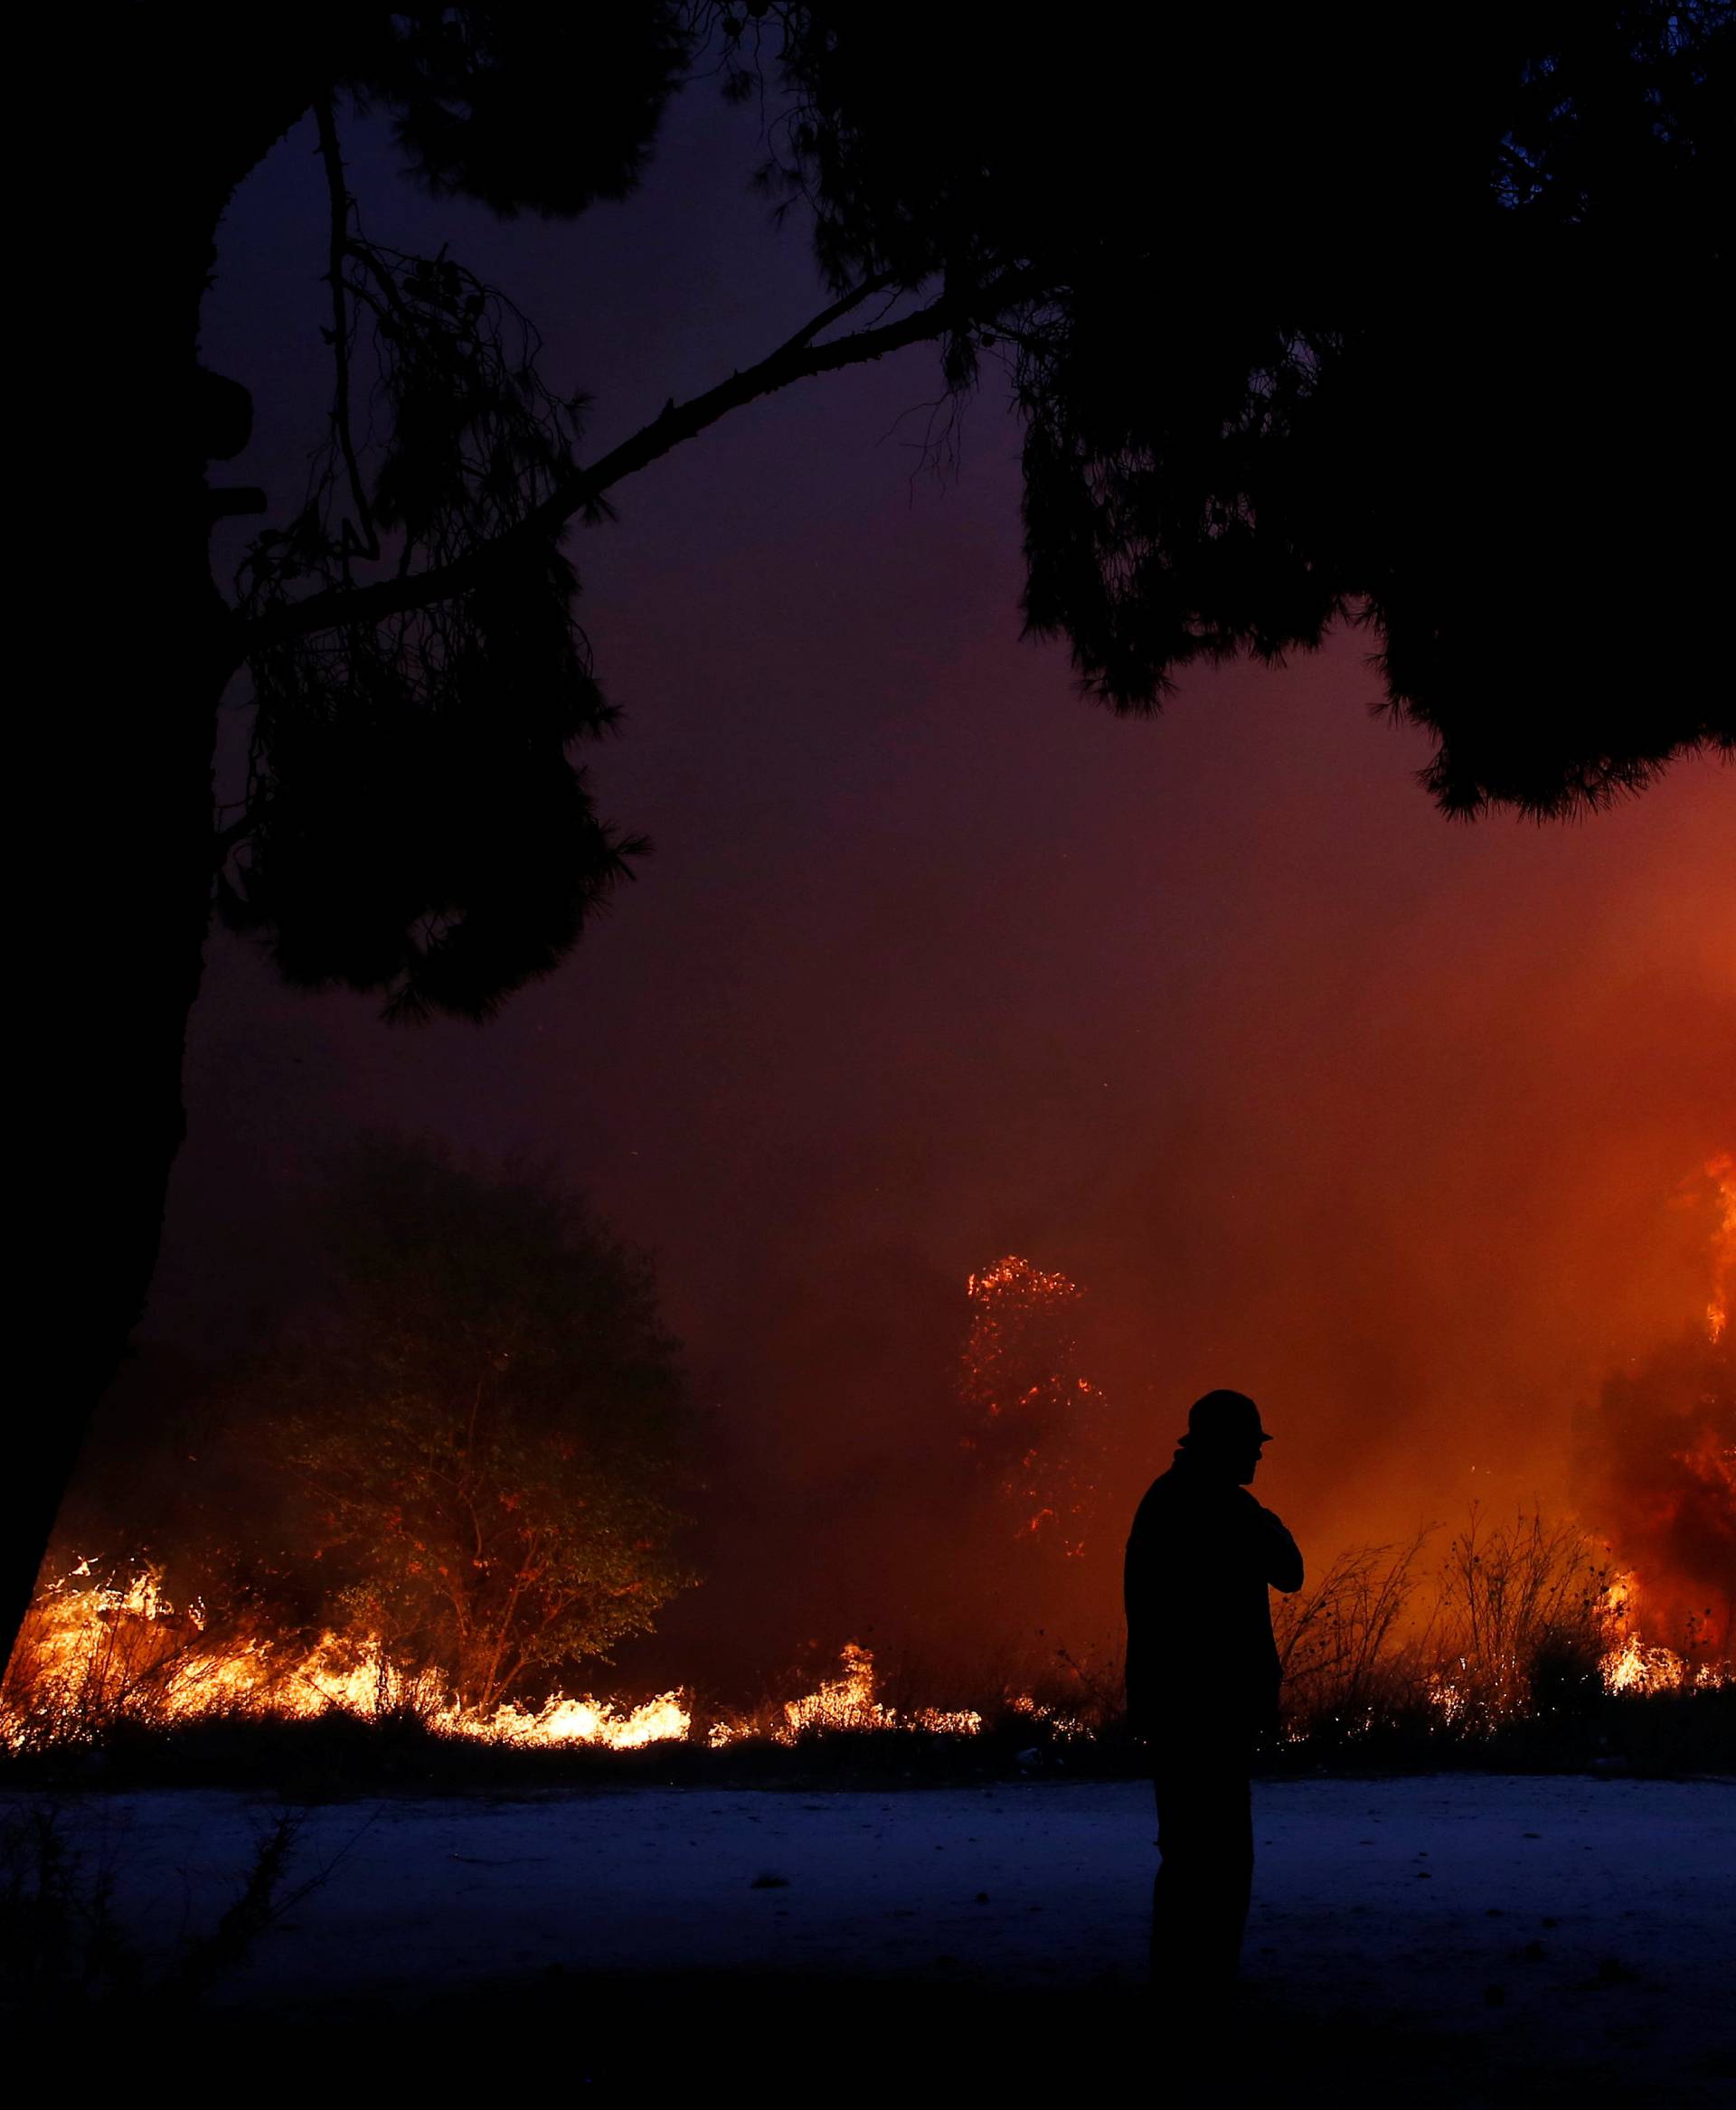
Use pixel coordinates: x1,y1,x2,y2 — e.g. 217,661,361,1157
0,11,312,1661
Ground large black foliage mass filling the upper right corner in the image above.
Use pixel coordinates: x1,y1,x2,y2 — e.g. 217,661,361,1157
742,0,1736,815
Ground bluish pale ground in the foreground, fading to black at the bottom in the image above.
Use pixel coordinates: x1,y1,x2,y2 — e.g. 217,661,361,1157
11,1775,1736,2110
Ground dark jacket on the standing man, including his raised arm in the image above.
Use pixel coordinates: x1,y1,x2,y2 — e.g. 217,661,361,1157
1124,1449,1301,1749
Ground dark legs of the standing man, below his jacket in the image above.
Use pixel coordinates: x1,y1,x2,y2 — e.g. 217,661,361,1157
1152,1751,1253,1992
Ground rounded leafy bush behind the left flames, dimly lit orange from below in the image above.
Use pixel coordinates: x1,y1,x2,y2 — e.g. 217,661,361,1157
232,1139,694,1713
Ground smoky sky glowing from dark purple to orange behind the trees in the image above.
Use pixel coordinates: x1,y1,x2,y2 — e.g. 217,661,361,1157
136,70,1736,1679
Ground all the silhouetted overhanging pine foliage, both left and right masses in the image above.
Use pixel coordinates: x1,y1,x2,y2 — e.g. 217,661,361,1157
223,0,1736,1015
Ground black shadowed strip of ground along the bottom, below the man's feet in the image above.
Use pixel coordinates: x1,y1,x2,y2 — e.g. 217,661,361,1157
180,1969,1736,2110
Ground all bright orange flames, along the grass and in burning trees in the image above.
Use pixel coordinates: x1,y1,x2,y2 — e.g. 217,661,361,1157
0,1154,1736,1751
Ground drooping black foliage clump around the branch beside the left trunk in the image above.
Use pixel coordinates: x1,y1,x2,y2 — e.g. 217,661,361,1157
220,226,639,1017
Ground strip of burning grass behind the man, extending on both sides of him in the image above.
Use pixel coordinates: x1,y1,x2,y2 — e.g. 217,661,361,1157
0,1517,1736,1794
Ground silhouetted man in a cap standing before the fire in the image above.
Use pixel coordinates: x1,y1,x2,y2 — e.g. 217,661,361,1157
1127,1392,1301,1998
